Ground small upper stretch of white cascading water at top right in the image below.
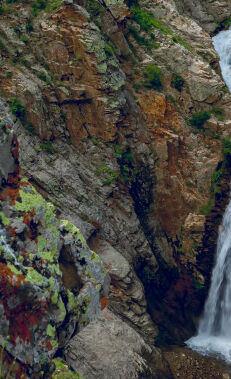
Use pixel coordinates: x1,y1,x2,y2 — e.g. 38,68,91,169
213,29,231,92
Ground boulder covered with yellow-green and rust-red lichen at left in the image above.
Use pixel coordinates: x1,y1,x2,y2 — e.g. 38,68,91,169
0,104,109,377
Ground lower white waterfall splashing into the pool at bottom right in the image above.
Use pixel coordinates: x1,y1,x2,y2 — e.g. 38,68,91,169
186,193,231,362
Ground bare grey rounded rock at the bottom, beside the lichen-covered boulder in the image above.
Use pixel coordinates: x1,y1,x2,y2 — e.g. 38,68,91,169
65,310,171,379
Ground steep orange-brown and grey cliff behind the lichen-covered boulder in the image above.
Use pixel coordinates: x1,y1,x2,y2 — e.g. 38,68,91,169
0,0,231,377
